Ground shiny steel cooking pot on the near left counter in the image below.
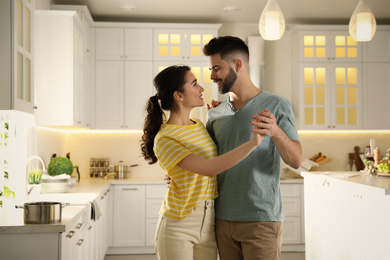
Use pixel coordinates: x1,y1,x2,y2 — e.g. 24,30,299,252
15,201,70,224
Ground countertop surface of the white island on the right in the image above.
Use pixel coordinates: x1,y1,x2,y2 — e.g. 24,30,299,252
302,171,390,195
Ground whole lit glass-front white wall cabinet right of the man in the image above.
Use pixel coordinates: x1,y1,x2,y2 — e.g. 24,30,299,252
293,26,363,129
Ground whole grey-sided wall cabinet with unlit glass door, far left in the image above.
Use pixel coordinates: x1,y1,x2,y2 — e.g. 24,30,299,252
0,0,35,113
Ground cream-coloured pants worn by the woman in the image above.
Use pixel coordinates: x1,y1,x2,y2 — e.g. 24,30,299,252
155,200,217,260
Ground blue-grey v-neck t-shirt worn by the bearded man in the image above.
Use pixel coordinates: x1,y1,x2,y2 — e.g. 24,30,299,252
206,90,299,222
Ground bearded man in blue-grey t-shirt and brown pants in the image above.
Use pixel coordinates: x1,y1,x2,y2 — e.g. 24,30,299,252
203,36,302,260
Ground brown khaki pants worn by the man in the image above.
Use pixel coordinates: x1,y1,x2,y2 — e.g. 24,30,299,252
215,219,282,260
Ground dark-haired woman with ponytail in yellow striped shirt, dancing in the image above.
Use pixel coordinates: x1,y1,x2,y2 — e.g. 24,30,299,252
141,66,263,260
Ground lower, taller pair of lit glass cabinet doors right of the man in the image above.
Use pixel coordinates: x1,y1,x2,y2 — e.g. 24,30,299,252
300,63,362,129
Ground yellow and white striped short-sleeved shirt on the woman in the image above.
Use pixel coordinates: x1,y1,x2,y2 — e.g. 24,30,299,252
153,119,218,220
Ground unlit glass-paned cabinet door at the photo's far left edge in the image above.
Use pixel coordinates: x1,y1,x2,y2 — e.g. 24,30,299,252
13,0,34,113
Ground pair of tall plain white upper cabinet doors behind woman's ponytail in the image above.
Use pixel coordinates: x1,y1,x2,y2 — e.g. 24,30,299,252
95,61,153,130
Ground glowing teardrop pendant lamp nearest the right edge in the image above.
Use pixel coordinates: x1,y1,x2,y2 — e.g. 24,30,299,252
349,0,376,42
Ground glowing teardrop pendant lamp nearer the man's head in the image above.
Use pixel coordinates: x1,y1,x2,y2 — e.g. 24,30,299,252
259,0,285,41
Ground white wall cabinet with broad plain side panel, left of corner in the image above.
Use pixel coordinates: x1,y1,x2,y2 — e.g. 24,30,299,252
35,10,91,128
